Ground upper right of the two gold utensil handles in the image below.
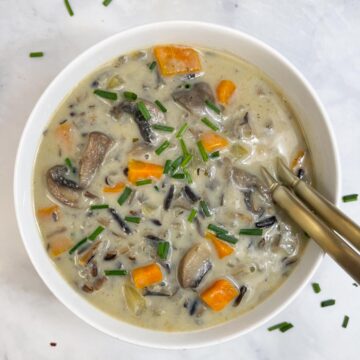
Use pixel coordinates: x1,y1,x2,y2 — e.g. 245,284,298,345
278,160,360,252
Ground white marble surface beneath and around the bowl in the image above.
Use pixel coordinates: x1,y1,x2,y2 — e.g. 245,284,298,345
0,0,360,360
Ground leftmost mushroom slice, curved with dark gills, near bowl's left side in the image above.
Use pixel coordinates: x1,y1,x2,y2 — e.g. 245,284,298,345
46,165,80,208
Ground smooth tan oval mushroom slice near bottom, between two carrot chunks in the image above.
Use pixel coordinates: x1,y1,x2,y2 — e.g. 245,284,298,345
178,243,212,289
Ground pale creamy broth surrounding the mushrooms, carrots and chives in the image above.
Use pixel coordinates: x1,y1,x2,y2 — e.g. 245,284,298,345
34,45,311,331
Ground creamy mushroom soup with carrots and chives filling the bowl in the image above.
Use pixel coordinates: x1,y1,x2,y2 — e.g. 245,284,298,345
34,45,311,331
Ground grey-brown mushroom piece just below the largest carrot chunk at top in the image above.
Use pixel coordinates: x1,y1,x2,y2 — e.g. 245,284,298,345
172,82,214,115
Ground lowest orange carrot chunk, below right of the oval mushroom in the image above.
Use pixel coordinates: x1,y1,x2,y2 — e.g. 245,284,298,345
200,279,239,311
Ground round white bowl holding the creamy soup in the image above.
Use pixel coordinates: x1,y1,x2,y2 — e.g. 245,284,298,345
14,21,340,349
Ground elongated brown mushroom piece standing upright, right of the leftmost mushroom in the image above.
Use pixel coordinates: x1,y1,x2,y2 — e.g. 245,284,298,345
79,131,112,188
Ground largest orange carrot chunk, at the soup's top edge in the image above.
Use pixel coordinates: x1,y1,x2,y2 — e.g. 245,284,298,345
154,45,201,76
